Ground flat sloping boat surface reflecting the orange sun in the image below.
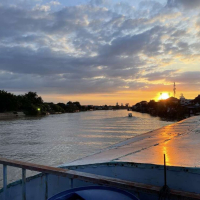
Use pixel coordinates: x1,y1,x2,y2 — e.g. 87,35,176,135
62,116,200,167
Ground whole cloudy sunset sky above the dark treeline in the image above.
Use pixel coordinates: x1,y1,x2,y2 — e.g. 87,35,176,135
0,0,200,105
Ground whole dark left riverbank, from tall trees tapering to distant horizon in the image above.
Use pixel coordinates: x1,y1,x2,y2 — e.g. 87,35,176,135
0,90,128,117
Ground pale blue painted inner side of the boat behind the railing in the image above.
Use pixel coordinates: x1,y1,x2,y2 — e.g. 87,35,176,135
0,162,200,200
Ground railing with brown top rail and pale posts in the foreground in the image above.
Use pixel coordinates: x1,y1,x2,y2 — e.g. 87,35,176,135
0,158,200,200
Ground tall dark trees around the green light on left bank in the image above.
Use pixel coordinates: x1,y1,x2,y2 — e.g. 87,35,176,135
0,90,85,115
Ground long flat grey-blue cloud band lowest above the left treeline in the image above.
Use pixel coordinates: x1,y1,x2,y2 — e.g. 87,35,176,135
0,72,147,94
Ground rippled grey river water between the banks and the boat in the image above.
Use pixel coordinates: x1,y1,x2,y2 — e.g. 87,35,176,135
0,110,172,186
